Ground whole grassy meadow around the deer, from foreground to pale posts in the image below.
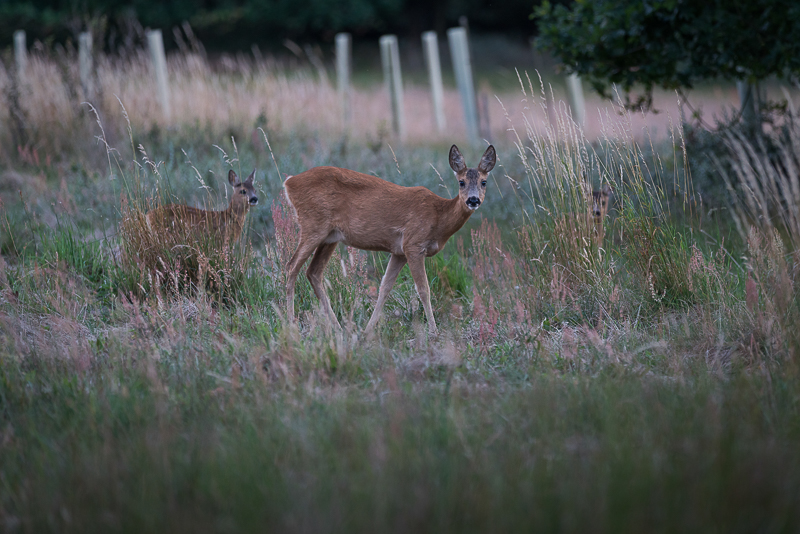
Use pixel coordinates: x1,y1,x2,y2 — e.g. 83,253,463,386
0,40,800,533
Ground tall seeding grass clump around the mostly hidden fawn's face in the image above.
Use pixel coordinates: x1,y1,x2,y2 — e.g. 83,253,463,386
484,73,722,332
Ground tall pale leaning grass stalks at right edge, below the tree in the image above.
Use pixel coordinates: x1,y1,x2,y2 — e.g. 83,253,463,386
717,109,800,367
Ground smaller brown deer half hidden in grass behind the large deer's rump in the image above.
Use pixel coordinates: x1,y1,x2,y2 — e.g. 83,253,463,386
147,169,258,243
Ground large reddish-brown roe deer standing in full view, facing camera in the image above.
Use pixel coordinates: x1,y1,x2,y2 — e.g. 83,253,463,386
283,145,497,334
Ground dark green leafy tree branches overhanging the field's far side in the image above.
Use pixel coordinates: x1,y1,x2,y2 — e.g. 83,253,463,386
533,0,800,123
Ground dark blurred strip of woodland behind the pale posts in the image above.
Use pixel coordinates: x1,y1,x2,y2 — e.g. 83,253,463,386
0,0,534,50
